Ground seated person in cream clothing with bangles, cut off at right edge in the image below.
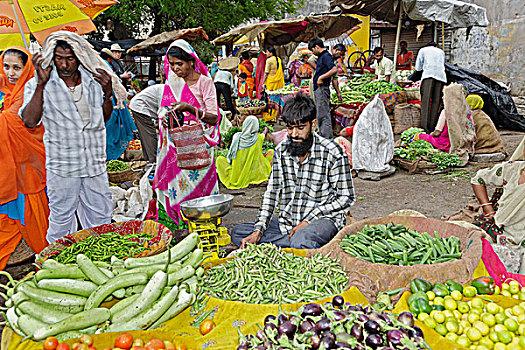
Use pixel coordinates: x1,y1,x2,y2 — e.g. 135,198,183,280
471,161,525,246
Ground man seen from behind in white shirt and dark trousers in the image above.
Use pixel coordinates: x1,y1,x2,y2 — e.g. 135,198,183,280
416,41,447,133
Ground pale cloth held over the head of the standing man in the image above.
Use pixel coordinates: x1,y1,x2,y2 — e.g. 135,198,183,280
42,31,127,108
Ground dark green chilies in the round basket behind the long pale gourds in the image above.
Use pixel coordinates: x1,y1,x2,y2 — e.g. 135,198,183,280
53,232,155,264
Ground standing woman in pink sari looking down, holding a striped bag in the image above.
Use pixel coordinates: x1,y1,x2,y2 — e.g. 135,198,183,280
153,40,220,224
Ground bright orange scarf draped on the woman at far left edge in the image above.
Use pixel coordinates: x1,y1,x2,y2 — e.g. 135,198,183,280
0,47,46,204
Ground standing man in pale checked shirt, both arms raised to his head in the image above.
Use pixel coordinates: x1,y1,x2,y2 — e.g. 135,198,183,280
19,33,113,243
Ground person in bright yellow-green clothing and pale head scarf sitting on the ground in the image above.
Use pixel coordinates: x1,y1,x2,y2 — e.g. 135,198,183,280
215,115,273,189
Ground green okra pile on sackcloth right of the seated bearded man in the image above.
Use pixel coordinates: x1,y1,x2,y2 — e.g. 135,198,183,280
340,223,462,266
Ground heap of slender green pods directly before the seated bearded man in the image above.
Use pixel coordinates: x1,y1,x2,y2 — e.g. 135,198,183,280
200,244,348,304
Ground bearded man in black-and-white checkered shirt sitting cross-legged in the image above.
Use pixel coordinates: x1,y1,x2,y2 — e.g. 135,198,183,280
231,94,355,249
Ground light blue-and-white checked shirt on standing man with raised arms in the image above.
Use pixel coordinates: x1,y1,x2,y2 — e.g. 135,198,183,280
18,66,106,177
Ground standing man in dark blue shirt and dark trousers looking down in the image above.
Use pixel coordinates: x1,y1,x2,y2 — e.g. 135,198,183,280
308,37,337,139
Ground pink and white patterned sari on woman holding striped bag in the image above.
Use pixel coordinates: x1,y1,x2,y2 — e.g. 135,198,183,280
153,40,220,224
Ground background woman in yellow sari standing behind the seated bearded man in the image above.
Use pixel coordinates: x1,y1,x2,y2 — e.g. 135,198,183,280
263,46,284,121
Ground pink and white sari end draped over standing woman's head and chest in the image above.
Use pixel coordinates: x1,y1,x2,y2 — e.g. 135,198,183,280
161,39,221,146
